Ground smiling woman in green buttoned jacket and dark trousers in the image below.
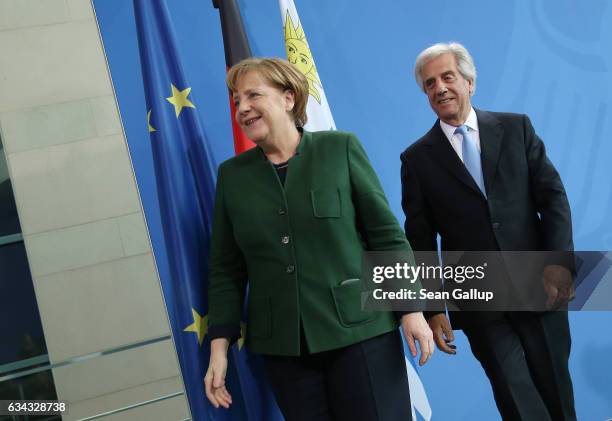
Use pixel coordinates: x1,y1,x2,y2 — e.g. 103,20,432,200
205,58,434,421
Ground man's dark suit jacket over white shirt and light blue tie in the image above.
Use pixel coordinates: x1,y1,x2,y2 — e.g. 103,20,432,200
401,110,573,328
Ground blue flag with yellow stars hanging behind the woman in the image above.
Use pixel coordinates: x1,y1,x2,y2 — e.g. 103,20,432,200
134,0,265,421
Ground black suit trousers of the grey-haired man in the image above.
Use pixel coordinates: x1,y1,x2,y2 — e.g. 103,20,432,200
463,311,576,421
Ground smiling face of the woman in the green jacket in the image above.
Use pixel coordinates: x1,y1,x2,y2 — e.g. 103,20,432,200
233,71,294,144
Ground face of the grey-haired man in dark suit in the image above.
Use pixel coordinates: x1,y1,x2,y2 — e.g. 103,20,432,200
421,53,473,126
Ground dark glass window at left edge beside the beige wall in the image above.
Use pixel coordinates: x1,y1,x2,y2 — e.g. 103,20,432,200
0,134,61,421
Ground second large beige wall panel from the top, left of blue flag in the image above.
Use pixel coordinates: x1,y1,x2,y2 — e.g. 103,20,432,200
8,135,140,235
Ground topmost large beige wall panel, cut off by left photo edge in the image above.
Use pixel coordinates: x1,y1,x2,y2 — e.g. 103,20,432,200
0,20,112,112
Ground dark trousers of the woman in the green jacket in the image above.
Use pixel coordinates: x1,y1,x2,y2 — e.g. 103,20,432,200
264,330,412,421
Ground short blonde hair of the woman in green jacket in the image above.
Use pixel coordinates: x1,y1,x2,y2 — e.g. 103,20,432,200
226,57,308,127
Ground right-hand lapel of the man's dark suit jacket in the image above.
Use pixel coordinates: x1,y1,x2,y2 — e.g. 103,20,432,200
476,110,504,192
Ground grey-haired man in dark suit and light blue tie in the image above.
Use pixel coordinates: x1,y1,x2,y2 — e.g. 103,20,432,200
401,43,576,421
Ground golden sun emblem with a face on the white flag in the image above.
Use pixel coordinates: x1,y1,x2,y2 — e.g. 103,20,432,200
285,10,321,104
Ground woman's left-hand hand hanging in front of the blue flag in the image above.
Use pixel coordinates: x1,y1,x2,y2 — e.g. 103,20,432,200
204,338,232,408
